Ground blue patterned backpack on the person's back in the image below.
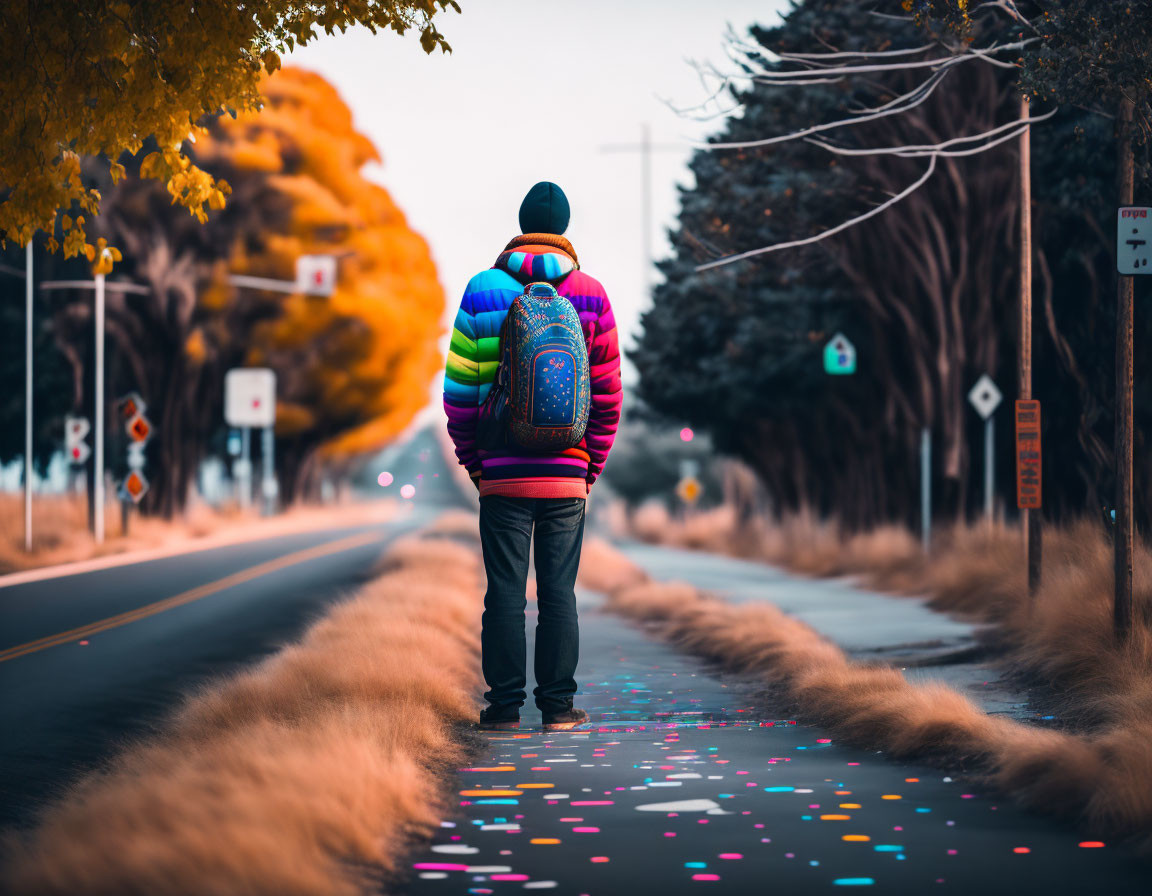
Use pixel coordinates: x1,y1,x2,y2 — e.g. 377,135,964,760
477,282,591,451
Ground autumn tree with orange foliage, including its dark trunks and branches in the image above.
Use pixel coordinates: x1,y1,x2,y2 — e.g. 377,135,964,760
38,68,444,516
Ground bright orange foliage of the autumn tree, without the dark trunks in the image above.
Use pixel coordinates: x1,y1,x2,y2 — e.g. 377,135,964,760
197,69,444,502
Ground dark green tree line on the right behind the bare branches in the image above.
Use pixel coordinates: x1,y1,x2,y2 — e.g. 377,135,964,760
632,0,1152,526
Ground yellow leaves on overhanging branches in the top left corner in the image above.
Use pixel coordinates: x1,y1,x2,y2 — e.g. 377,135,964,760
0,0,456,253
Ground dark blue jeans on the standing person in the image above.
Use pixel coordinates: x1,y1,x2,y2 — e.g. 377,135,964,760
480,495,585,716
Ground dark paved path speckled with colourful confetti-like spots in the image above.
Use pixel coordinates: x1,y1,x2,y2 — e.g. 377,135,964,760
406,594,1150,896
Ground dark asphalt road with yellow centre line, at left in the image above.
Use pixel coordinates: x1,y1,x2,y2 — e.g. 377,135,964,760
0,428,458,827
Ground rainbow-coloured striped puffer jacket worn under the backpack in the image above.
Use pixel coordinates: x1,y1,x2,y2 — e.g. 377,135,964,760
444,234,622,498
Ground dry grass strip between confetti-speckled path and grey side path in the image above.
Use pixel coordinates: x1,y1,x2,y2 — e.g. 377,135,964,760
585,542,1152,851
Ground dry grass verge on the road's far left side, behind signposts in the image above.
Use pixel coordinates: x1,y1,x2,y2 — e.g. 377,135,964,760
0,493,395,575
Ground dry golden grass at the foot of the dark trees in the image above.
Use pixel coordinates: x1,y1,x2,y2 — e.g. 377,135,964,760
636,507,1152,727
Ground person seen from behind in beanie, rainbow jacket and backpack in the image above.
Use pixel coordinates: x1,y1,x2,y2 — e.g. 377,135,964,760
444,182,622,730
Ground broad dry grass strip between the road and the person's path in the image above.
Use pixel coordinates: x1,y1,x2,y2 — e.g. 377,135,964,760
0,529,479,896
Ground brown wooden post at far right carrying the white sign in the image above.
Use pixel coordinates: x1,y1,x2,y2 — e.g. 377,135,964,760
1113,100,1135,640
